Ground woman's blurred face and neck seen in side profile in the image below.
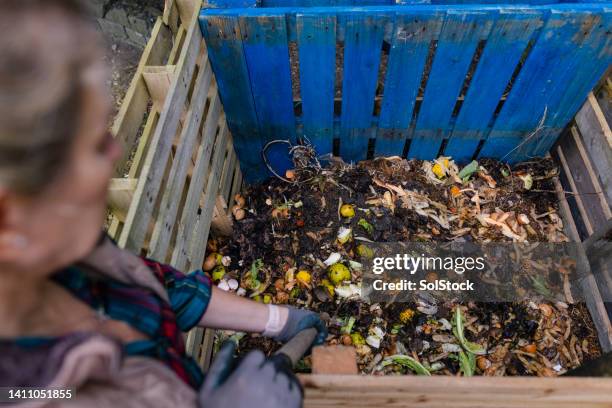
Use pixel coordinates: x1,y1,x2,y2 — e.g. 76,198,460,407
0,62,120,276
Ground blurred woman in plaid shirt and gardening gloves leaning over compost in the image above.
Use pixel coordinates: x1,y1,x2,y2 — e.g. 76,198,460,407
0,0,326,407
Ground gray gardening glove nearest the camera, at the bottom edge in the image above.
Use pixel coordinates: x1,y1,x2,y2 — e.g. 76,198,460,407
199,341,302,408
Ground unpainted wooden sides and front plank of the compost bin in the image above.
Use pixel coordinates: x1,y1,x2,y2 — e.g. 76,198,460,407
108,0,612,408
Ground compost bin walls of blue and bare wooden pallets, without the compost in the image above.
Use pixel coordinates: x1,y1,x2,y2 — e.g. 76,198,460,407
109,0,612,407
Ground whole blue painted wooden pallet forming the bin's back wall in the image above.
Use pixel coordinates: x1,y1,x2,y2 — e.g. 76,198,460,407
201,0,612,182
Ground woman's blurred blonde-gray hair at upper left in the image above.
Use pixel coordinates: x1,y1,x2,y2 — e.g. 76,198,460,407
0,0,98,194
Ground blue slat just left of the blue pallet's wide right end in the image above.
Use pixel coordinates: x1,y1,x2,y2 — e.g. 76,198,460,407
444,9,542,163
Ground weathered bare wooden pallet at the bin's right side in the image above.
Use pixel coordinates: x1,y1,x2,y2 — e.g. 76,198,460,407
551,78,612,344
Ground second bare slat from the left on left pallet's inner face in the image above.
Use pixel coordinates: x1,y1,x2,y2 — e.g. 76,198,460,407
149,55,212,259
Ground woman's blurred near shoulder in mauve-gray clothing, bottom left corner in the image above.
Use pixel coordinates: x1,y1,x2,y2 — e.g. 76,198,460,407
0,333,196,408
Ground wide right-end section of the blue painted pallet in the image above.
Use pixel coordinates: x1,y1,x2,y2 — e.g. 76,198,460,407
480,9,612,162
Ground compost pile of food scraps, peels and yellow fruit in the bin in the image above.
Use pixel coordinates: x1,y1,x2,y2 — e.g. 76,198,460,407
204,157,601,376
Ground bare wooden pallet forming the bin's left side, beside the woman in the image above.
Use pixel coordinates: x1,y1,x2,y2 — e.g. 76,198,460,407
108,0,242,360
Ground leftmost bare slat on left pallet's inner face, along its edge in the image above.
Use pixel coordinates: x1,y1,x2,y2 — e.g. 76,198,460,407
118,7,201,250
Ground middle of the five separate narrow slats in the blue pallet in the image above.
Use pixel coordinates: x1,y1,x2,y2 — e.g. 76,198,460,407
375,10,444,156
